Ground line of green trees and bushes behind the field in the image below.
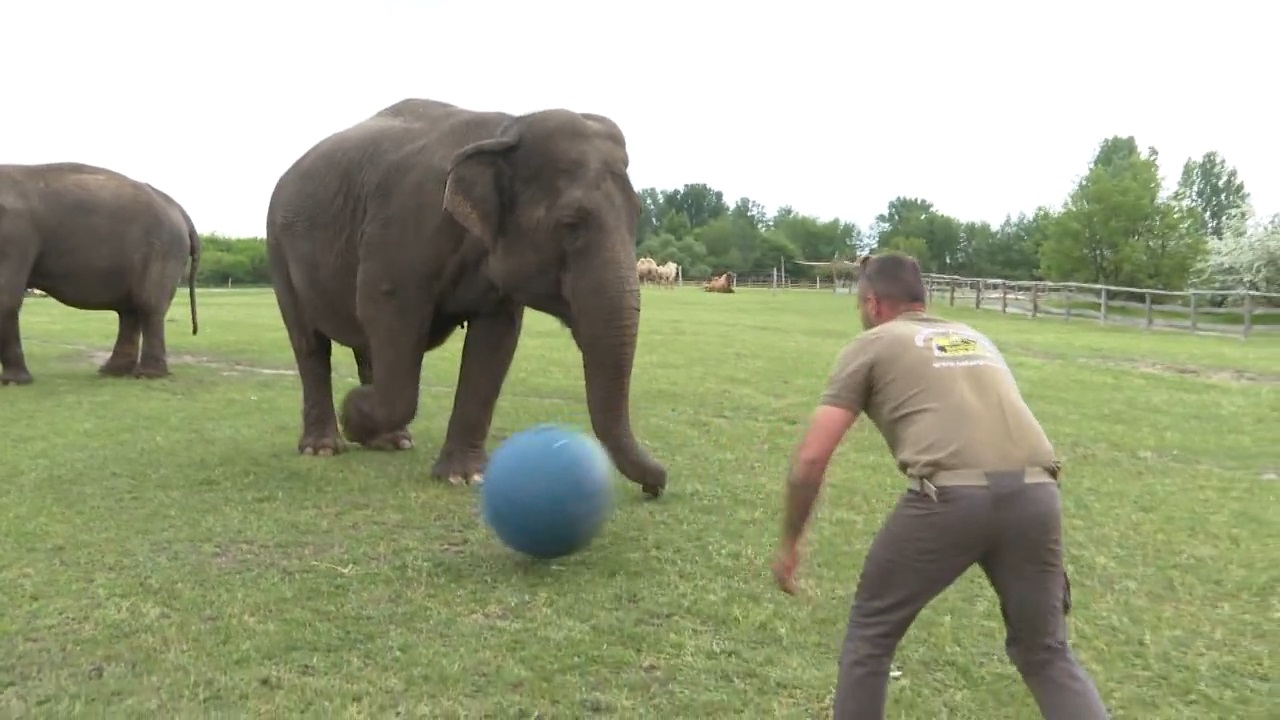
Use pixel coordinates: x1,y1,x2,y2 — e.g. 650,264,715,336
197,136,1280,292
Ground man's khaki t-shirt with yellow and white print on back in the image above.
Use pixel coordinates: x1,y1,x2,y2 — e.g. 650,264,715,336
820,313,1057,478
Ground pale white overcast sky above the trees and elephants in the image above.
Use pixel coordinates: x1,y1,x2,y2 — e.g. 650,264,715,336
0,0,1280,237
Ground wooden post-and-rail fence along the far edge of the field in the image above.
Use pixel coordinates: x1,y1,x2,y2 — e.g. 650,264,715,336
680,273,1280,337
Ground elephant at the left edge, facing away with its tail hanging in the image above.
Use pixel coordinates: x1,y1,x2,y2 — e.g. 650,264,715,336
0,163,200,384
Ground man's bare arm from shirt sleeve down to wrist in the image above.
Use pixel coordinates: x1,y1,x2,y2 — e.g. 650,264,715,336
782,405,858,547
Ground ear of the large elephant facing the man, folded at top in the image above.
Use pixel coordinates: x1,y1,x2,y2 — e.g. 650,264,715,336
444,137,517,247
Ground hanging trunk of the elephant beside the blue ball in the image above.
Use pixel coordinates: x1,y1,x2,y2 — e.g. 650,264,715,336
568,252,667,496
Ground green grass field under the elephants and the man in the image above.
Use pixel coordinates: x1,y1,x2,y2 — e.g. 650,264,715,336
0,290,1280,720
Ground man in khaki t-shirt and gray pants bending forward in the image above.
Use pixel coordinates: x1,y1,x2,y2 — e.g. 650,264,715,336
773,254,1107,720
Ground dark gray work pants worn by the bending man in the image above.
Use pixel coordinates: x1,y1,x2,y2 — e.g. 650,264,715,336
832,474,1107,720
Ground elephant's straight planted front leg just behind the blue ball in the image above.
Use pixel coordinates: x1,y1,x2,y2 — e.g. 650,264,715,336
431,307,524,484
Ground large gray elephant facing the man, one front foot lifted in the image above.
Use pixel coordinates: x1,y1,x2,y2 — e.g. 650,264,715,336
266,99,667,496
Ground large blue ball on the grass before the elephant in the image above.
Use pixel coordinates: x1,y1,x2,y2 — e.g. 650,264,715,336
480,425,613,560
